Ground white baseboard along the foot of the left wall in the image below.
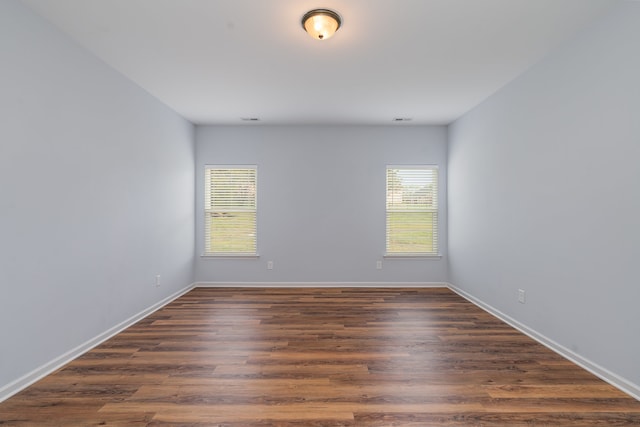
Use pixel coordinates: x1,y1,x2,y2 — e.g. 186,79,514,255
0,284,194,402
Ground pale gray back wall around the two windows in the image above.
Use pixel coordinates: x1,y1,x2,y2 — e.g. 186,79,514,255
196,126,447,283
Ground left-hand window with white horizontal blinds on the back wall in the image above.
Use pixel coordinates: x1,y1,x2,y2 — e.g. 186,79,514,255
204,166,258,256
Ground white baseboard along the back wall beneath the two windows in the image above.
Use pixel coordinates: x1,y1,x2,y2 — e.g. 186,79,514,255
195,282,449,288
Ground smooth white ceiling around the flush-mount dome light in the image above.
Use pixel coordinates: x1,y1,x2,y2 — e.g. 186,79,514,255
23,0,616,124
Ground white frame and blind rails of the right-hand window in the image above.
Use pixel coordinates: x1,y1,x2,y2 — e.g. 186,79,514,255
384,165,441,258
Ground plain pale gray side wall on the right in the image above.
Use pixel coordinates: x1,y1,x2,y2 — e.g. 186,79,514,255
449,2,640,393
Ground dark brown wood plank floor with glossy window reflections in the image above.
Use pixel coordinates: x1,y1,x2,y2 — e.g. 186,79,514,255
0,288,640,427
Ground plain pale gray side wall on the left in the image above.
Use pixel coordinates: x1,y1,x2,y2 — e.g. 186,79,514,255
0,0,194,394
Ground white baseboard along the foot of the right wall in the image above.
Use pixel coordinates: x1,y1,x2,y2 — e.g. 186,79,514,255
447,283,640,400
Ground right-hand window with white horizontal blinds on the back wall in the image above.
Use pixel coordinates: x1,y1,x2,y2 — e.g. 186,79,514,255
386,166,439,256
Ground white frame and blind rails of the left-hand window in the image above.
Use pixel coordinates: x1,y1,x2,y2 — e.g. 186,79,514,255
203,165,258,258
